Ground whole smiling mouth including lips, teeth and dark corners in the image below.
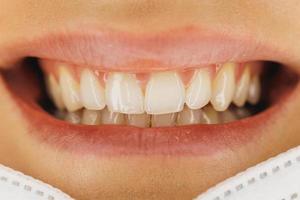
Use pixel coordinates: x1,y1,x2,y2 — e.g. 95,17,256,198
2,27,299,155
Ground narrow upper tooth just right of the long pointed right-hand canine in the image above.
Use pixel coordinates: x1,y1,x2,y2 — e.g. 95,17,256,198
233,66,250,107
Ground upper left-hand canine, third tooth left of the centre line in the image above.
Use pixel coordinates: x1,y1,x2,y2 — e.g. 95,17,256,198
59,67,82,112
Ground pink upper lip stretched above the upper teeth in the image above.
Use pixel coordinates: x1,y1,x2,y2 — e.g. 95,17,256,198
0,26,293,72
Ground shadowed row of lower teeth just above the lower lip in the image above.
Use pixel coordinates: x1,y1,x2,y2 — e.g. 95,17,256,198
55,105,251,127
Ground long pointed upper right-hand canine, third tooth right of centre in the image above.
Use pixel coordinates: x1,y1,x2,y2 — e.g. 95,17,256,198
211,63,235,111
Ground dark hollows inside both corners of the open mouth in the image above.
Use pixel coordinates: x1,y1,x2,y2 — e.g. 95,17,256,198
2,57,298,125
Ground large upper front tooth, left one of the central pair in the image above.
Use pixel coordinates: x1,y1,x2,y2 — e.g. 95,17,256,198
105,73,144,114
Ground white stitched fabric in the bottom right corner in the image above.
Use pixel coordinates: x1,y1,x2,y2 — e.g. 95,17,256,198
196,147,300,200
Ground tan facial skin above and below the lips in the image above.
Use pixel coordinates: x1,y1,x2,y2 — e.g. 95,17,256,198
0,0,300,200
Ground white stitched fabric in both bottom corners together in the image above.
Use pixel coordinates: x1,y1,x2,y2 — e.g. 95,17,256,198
0,146,300,200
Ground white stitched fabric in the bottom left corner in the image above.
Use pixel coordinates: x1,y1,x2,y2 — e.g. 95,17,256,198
0,165,72,200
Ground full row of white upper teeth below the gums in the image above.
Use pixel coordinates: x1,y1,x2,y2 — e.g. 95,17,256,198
47,63,260,114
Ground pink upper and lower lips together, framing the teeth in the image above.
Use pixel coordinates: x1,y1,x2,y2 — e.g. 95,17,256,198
0,27,299,155
